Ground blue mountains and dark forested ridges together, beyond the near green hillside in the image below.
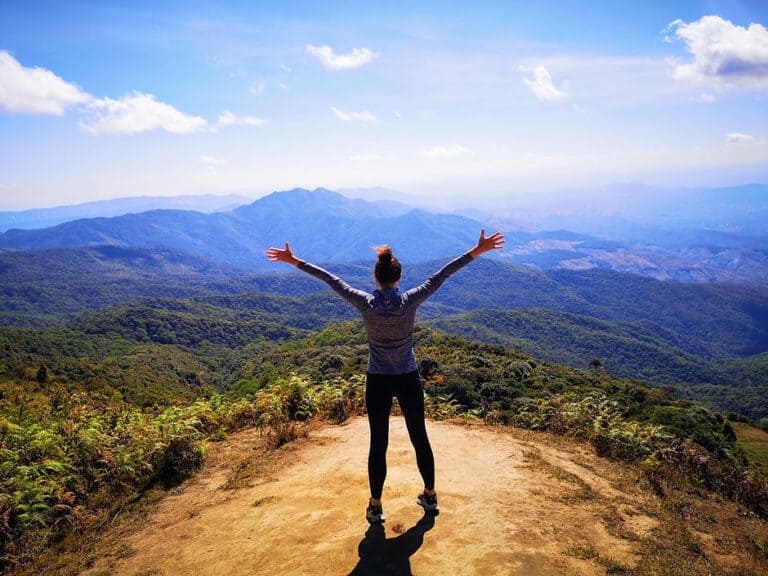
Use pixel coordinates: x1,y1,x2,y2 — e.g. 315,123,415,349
0,189,768,420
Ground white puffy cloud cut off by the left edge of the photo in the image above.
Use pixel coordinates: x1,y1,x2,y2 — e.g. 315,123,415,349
0,51,92,116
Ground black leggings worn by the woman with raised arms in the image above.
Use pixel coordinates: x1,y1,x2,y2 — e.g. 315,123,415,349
365,372,435,500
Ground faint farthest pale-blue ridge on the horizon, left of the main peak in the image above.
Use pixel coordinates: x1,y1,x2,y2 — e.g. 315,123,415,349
0,194,251,232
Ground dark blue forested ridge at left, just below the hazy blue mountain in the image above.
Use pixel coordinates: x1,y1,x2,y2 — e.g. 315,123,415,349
0,246,330,327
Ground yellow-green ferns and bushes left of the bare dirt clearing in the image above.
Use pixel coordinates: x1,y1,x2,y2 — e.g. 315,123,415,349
0,376,363,569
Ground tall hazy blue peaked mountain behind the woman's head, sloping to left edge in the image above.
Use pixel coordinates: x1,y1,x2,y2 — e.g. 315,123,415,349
0,188,492,268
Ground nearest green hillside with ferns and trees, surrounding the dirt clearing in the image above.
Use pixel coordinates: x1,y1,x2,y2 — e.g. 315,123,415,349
0,312,768,567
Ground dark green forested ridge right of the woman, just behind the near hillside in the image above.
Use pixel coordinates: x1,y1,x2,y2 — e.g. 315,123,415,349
429,308,768,421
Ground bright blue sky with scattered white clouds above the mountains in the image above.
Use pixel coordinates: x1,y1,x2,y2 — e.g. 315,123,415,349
0,0,768,210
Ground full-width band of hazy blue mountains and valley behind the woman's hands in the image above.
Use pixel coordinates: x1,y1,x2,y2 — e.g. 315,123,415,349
0,188,768,285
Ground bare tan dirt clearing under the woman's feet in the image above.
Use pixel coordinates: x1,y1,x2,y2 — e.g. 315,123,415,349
82,418,668,576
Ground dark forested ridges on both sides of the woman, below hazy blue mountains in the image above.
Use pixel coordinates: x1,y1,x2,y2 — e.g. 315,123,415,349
0,247,768,421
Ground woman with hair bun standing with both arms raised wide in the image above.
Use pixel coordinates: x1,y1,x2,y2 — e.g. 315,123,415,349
267,230,504,524
